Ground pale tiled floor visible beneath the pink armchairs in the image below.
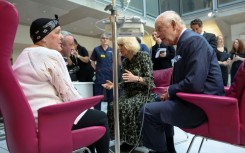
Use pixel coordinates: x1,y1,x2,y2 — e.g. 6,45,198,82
0,125,245,153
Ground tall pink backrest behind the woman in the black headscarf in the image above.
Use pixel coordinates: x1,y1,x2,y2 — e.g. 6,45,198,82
0,0,38,153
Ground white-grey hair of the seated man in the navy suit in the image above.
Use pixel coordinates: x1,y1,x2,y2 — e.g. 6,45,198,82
156,11,186,28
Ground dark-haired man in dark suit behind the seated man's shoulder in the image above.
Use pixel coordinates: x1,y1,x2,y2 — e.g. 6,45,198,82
190,19,217,50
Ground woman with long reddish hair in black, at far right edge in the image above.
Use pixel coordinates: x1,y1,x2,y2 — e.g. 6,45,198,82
230,39,245,83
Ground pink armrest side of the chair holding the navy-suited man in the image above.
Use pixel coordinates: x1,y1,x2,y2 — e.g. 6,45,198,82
177,92,240,140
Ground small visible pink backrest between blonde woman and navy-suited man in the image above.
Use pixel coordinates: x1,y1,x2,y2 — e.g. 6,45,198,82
153,68,173,87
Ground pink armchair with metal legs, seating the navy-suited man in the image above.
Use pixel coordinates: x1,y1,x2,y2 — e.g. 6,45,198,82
177,61,245,152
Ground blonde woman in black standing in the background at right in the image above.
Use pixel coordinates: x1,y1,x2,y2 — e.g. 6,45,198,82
216,35,231,86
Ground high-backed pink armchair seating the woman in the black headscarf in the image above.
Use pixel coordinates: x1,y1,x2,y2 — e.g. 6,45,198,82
0,0,105,153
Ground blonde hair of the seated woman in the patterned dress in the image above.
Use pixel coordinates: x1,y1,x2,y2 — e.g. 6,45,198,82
117,37,140,55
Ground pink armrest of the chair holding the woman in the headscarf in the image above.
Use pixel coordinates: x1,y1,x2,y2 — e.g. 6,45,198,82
38,95,104,152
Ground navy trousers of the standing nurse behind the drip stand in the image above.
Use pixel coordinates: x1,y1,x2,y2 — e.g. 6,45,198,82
94,84,113,110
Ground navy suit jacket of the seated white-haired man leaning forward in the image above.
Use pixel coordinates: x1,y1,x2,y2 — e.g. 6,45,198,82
168,30,224,99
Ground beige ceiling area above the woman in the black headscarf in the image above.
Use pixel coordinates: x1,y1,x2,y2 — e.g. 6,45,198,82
9,0,117,37
